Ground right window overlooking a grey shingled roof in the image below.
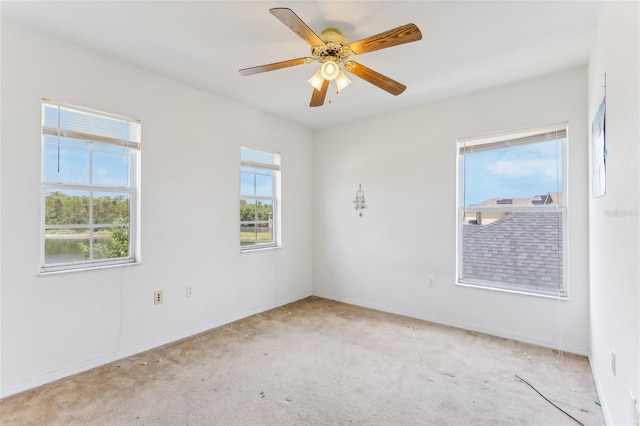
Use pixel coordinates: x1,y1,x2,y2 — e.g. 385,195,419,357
458,124,567,297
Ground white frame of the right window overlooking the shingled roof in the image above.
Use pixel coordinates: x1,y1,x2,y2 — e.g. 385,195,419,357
455,122,569,300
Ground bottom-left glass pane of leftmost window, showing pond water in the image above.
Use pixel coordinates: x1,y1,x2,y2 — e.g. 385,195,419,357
44,228,89,264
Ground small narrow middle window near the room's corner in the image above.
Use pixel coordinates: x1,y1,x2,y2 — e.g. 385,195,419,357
240,146,280,250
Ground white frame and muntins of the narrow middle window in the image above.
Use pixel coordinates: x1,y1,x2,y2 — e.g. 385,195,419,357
238,145,282,252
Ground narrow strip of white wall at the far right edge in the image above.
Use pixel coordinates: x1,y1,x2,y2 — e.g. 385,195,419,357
588,2,640,425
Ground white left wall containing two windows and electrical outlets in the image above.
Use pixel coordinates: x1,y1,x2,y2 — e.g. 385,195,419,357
0,22,312,396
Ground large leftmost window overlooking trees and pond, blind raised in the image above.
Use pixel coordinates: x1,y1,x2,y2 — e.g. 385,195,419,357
41,100,141,272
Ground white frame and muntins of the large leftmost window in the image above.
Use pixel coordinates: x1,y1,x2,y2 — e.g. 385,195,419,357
40,99,141,274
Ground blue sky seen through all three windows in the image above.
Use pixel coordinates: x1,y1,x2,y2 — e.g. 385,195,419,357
44,137,562,206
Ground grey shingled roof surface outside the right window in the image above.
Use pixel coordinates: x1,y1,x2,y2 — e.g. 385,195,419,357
463,211,563,290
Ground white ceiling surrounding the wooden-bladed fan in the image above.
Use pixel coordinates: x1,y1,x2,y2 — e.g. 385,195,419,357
1,0,600,129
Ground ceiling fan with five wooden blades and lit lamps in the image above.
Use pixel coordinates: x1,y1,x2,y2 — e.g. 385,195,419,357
240,7,422,107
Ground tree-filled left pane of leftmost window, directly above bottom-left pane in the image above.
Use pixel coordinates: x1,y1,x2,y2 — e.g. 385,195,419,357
45,190,89,225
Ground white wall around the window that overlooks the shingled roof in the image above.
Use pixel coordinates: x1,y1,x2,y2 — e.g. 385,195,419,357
313,68,589,354
